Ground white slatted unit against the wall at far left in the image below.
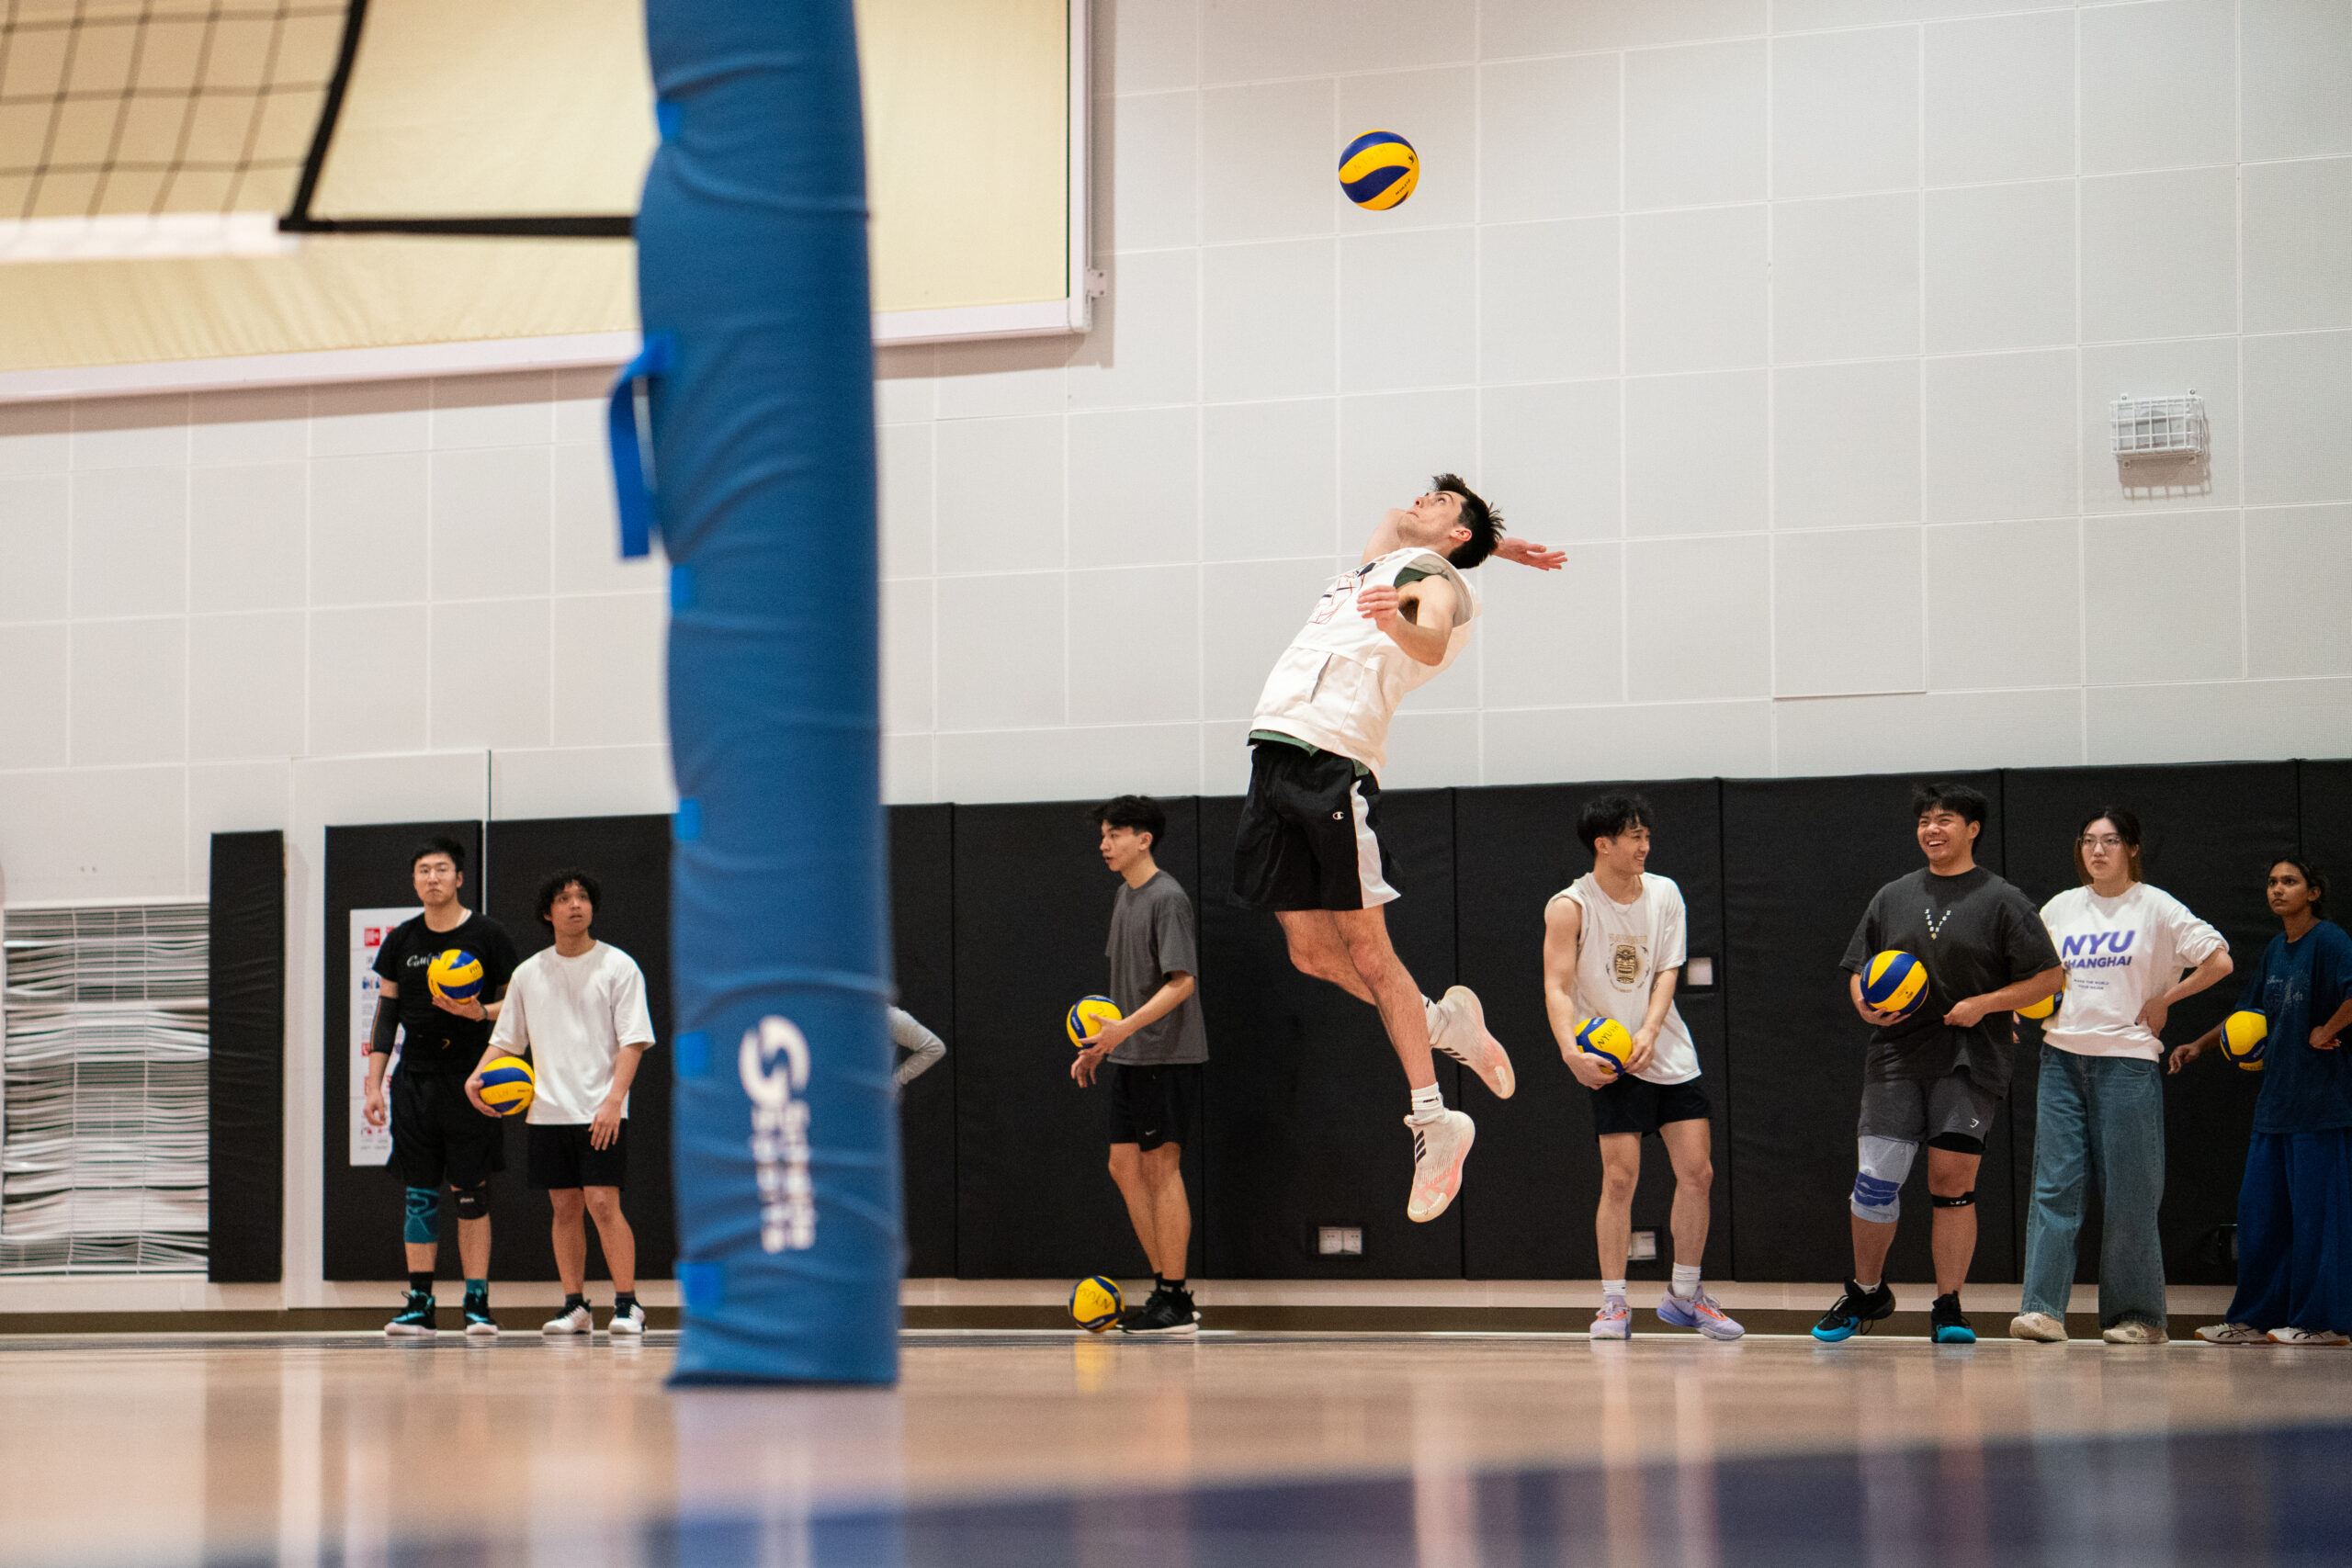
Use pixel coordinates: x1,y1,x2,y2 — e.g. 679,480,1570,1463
0,903,209,1274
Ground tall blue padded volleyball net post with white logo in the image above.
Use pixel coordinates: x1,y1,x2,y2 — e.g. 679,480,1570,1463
639,0,899,1382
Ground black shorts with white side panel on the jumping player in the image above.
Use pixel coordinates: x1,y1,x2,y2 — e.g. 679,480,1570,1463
1232,740,1397,909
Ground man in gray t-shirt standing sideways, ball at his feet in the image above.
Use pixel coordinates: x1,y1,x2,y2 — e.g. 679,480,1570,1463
1070,795,1209,1333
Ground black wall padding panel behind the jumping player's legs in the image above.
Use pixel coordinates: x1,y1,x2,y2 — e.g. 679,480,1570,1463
1200,790,1479,1279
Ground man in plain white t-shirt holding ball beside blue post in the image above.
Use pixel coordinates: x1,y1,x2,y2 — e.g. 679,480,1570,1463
466,870,654,1336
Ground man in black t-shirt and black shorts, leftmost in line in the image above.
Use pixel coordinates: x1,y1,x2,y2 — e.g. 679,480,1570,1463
365,837,515,1337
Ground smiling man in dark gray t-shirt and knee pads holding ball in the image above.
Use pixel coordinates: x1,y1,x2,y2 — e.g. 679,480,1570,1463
1814,783,2065,1345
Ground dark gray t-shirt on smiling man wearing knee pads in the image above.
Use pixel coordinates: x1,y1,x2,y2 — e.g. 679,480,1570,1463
1844,865,2058,1093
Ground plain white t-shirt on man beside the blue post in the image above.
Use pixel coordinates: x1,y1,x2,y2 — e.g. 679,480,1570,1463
489,942,654,1126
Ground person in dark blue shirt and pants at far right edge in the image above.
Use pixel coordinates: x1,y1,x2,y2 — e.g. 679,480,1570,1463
2171,856,2352,1345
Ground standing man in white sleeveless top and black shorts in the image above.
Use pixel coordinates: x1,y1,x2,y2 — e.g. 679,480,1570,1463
1543,795,1743,1340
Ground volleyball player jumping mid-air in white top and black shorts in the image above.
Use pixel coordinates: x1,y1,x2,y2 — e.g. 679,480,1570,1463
1232,475,1566,1220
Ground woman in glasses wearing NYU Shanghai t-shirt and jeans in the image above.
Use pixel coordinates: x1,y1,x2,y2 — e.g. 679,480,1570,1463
2008,807,2230,1345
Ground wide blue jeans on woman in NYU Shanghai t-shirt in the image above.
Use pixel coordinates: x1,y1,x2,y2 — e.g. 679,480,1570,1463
2025,1046,2164,1328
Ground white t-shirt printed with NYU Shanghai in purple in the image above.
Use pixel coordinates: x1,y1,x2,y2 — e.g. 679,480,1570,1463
2041,882,2227,1063
